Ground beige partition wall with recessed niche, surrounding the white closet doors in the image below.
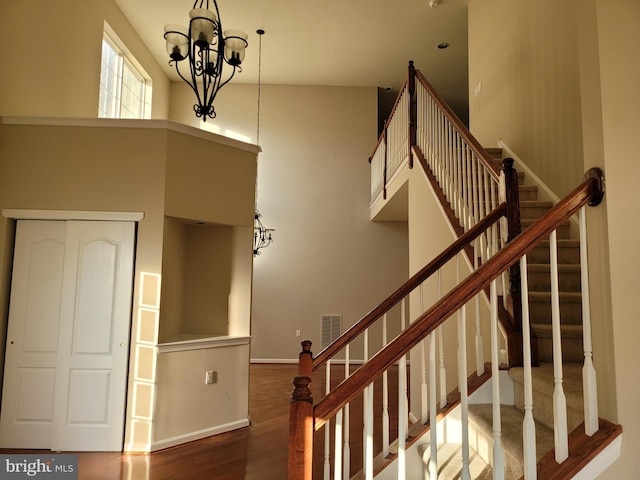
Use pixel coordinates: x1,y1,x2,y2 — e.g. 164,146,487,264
0,119,256,451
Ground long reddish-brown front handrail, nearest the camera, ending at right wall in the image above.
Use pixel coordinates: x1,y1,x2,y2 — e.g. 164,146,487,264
314,169,604,430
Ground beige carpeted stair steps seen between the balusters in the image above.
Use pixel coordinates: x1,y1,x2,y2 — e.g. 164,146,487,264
456,148,584,480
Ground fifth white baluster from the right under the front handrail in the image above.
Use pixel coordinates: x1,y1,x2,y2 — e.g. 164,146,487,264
456,254,471,480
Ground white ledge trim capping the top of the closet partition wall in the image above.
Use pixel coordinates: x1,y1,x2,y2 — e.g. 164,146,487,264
1,117,262,155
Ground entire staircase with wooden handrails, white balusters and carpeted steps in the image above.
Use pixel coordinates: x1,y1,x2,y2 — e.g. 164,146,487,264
289,63,621,480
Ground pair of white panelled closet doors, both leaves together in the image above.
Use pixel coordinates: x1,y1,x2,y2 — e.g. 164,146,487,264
0,221,135,451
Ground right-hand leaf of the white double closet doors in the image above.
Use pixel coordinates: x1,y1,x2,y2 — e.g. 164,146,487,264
52,222,134,451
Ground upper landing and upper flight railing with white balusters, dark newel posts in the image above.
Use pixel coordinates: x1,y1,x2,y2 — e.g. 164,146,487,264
369,62,524,365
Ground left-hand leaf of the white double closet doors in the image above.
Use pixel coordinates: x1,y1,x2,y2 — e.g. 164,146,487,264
0,221,66,449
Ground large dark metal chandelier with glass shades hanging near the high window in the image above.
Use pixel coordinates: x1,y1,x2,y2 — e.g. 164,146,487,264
164,0,248,121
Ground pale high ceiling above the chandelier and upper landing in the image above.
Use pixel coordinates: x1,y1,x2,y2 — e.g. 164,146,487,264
115,0,469,119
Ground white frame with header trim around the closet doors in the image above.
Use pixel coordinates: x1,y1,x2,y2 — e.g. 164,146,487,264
0,208,144,450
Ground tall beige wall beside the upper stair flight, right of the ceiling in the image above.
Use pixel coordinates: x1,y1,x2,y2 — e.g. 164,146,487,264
469,0,583,197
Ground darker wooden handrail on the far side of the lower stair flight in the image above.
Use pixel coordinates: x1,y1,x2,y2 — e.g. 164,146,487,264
313,203,507,371
